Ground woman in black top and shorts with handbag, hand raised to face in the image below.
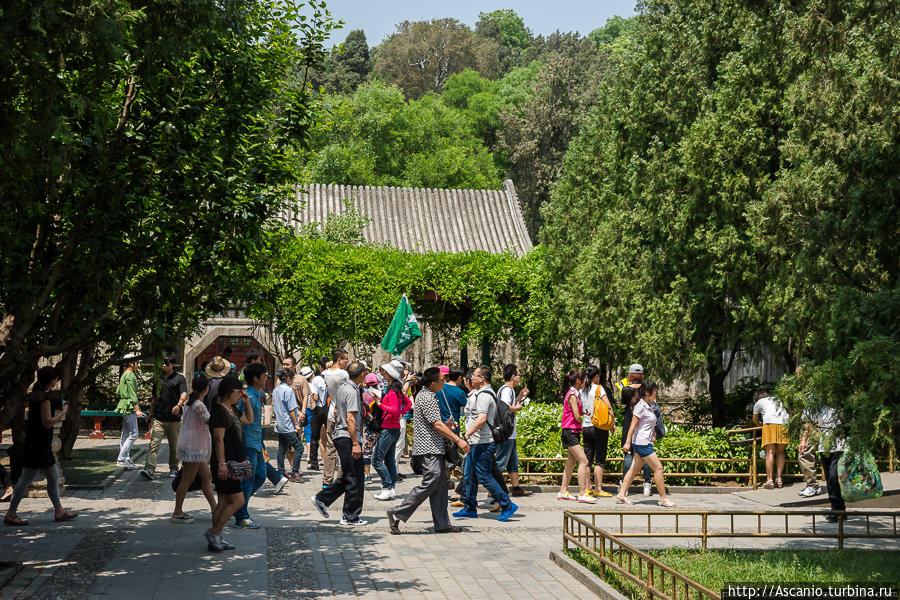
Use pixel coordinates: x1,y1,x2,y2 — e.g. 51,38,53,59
204,375,253,552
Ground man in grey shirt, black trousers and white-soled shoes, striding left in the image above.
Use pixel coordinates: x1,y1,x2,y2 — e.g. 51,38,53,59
312,361,368,525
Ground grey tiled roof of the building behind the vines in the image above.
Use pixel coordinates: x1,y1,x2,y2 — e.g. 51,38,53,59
295,179,532,256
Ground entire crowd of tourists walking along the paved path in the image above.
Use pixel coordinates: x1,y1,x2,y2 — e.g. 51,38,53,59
2,348,845,552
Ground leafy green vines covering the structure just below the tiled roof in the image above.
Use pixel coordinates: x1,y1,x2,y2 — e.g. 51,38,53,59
248,235,543,368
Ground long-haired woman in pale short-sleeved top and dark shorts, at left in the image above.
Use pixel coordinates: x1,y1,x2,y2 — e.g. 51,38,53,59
172,374,216,523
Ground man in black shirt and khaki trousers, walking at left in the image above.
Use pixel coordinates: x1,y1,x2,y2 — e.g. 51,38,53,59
141,352,187,481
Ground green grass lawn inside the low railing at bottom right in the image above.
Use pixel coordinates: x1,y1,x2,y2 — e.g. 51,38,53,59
568,548,900,600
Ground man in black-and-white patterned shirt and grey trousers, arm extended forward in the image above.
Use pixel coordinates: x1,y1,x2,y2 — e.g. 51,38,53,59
387,367,469,535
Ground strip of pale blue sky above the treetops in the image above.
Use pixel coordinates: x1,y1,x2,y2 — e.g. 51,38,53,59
326,0,635,46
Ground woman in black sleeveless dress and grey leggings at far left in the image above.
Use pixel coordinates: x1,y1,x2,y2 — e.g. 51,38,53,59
3,367,78,526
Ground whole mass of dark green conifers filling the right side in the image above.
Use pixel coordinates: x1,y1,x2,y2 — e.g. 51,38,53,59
542,0,900,444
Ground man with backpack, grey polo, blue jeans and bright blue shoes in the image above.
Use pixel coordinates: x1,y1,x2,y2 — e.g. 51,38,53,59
453,365,519,521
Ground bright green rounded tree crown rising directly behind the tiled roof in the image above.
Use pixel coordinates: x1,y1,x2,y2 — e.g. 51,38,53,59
306,81,501,189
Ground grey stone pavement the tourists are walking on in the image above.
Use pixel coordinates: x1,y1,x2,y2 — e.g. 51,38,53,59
0,439,896,600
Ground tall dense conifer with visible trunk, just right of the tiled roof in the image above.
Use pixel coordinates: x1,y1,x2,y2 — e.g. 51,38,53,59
542,0,785,426
